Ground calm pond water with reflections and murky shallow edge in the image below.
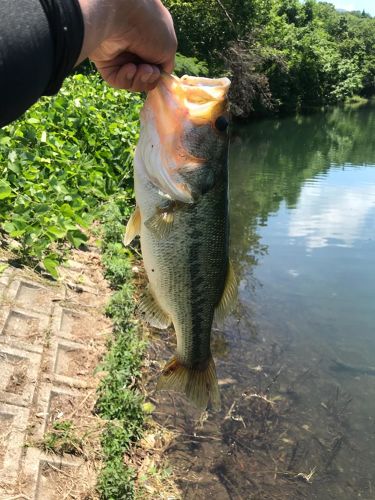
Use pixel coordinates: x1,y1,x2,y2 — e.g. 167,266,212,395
150,105,375,500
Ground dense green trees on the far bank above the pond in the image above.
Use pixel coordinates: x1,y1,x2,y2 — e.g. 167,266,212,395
166,0,375,118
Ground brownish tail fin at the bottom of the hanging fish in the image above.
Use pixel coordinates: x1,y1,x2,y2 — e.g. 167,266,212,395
156,357,220,410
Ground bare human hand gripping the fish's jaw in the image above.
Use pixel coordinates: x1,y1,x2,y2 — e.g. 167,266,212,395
77,0,177,92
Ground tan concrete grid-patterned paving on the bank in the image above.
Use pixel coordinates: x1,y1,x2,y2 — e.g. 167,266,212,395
0,252,110,500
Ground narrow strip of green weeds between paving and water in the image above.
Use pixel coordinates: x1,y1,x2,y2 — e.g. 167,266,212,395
96,198,147,500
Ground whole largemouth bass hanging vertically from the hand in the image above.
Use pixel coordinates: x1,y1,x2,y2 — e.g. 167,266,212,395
125,75,237,409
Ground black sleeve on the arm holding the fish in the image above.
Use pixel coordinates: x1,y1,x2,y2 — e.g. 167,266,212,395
0,0,84,127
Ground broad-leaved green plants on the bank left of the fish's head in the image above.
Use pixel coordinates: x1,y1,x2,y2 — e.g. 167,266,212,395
0,74,142,277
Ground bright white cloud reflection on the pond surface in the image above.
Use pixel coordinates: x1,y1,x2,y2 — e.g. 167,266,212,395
288,170,375,250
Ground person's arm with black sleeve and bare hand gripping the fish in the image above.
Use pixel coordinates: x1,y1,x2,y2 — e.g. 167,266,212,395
0,0,177,127
